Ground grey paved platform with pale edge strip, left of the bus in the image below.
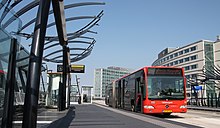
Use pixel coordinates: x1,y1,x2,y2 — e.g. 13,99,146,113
30,103,199,128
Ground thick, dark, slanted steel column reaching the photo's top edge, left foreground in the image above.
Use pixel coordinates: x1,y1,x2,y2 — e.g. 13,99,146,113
22,0,51,128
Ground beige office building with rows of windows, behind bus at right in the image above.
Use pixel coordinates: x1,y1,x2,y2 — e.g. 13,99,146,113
152,37,220,100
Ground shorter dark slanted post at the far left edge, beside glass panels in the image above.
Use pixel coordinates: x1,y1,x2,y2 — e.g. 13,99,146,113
2,39,17,128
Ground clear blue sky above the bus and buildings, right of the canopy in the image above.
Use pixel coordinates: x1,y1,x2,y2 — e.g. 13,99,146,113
74,0,220,85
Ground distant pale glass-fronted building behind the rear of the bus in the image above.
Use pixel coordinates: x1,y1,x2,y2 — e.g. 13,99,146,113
94,67,132,98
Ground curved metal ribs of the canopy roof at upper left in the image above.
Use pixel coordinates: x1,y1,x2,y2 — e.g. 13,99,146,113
0,0,105,63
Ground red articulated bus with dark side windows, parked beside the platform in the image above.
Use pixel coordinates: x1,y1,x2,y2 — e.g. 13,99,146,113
105,66,187,115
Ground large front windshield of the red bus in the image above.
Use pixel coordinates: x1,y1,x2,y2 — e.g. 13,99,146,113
147,76,185,100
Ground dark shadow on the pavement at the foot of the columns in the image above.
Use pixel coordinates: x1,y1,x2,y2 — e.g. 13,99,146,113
46,106,75,128
